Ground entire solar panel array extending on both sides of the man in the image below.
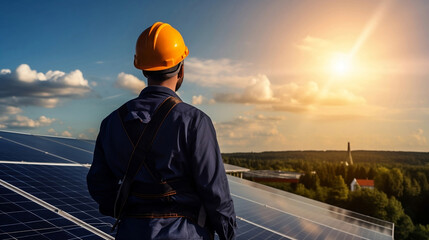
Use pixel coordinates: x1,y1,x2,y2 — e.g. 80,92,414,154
0,131,393,239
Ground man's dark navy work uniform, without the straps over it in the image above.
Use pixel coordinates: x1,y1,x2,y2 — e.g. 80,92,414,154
87,86,236,239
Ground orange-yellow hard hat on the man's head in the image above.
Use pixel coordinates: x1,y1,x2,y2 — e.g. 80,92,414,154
134,22,189,71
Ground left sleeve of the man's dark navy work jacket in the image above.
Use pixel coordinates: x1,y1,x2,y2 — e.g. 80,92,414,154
86,123,119,217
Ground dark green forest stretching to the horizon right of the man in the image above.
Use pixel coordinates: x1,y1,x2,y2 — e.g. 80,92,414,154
223,151,429,239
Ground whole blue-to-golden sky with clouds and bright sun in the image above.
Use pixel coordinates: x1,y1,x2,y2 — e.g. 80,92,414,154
0,0,429,152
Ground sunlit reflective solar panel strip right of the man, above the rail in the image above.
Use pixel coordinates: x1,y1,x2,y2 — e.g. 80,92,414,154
229,177,392,239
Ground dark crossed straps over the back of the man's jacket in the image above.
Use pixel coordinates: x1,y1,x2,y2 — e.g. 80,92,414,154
112,97,181,231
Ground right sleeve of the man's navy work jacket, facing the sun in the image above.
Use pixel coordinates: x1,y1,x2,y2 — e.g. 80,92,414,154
193,116,237,239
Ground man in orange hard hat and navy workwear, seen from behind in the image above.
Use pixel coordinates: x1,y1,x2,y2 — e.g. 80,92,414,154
87,22,236,239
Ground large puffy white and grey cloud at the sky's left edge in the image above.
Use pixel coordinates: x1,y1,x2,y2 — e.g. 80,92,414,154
0,64,91,108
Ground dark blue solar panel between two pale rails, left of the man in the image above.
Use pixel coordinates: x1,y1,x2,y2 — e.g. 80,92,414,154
0,163,114,236
